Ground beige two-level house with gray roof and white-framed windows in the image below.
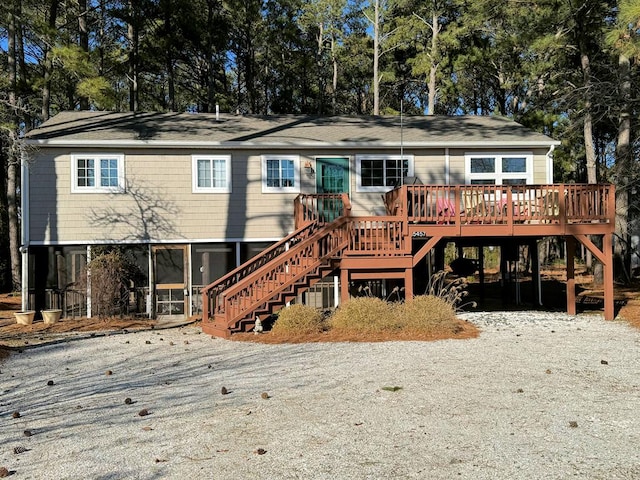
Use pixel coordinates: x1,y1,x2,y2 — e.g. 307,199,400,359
22,112,559,317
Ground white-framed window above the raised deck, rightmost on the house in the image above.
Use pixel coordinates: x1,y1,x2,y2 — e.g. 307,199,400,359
465,152,533,185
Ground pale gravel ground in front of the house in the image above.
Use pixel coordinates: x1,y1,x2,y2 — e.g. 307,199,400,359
0,312,640,480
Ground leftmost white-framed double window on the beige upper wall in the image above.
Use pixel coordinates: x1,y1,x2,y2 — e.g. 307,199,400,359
71,153,125,193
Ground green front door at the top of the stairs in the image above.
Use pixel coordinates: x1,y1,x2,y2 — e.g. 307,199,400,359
316,157,349,222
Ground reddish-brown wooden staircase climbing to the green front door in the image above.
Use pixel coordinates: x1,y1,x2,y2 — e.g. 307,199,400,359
202,195,351,338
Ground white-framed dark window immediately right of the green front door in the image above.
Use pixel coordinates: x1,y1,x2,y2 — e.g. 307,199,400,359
356,155,413,192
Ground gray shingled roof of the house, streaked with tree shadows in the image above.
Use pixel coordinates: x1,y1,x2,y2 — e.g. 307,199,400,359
26,111,559,148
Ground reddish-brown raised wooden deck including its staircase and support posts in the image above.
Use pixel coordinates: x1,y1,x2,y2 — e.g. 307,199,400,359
203,184,615,336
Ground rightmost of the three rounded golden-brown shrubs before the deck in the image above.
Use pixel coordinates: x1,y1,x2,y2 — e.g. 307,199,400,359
396,295,460,333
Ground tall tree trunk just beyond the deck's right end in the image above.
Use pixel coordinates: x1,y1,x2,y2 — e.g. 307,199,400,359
614,54,633,282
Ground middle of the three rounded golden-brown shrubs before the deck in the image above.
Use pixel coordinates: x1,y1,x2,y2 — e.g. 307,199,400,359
330,297,399,333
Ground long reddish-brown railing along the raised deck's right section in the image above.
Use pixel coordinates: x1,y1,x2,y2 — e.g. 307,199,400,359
385,184,615,225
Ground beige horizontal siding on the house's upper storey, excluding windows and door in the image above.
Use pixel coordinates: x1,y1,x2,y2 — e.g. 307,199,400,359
28,148,547,244
